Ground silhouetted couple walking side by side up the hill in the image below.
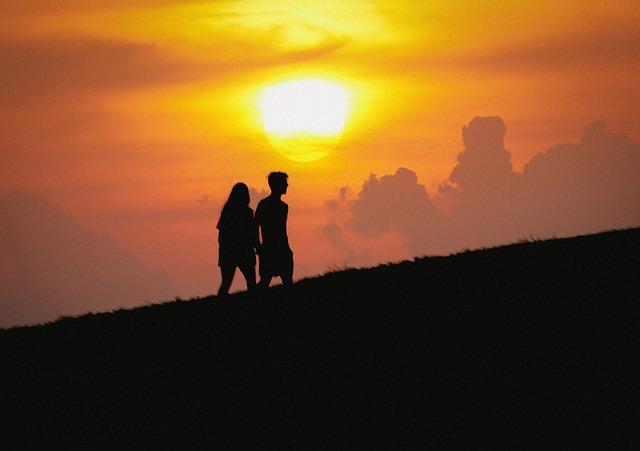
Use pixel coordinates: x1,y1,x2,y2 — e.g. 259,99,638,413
217,172,293,295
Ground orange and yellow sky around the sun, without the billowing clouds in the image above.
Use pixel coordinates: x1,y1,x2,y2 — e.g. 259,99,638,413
0,0,640,327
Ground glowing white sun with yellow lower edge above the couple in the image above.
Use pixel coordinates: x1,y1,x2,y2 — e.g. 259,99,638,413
258,79,349,161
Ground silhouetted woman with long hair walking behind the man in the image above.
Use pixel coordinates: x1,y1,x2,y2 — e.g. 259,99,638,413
217,183,258,295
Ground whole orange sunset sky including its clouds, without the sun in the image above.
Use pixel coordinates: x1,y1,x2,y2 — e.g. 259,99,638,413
0,0,640,327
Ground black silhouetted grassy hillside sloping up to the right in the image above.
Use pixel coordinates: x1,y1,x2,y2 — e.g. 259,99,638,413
0,228,640,449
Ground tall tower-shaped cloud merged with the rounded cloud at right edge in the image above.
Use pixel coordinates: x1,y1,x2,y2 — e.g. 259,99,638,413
449,118,640,246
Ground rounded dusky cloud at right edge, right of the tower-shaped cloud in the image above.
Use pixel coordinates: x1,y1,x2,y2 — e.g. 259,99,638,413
520,122,640,235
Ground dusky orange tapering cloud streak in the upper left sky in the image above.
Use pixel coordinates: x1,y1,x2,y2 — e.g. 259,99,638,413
0,37,201,108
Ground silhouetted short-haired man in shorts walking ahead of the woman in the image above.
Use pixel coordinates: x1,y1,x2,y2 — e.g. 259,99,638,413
256,172,293,288
